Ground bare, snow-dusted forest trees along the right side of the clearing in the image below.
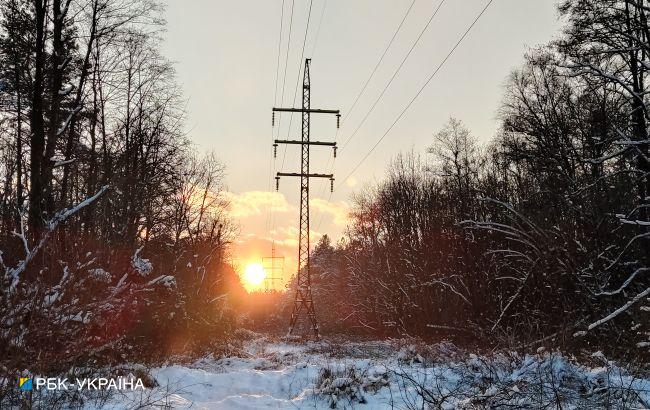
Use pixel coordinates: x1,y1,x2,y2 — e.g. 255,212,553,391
288,0,650,355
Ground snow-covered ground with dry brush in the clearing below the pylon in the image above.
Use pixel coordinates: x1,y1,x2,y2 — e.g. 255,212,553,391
97,338,650,409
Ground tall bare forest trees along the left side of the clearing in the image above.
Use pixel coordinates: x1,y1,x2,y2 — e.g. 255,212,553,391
0,0,242,387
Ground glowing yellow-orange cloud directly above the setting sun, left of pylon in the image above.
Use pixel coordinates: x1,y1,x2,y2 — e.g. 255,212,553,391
224,191,292,218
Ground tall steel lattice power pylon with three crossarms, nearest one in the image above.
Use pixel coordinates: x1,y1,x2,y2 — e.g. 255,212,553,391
273,58,341,338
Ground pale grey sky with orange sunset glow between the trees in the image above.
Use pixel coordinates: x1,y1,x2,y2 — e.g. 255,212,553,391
162,0,561,288
